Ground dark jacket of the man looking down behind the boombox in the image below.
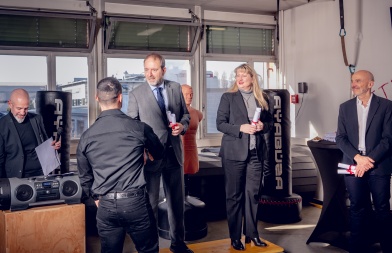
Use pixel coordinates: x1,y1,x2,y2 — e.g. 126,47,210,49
0,112,48,178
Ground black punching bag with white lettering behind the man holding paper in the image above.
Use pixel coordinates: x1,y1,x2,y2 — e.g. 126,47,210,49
36,91,72,174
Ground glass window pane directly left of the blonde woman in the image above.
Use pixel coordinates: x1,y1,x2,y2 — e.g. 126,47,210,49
206,61,245,134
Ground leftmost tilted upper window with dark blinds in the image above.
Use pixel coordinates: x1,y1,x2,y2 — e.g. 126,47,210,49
0,10,95,52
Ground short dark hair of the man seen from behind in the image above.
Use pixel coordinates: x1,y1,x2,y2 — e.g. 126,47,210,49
97,77,122,104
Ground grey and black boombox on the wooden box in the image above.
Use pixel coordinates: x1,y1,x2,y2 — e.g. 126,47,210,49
0,173,82,211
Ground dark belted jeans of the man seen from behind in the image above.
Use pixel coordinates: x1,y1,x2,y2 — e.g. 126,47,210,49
97,189,159,253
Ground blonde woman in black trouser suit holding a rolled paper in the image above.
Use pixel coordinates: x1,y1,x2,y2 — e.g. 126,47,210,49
216,64,272,250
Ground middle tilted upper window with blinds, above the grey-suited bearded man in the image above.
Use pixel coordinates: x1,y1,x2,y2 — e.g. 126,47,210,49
105,17,200,54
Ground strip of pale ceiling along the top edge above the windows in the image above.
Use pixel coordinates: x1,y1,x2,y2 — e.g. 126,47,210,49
105,0,334,14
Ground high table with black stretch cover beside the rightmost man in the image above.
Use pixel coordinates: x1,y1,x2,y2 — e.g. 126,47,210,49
306,140,349,250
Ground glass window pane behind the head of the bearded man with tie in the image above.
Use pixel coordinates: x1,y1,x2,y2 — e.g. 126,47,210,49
107,58,191,113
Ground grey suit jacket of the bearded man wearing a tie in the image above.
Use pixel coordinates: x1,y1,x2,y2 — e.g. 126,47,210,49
128,80,190,170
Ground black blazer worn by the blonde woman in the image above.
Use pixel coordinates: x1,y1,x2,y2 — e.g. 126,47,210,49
216,91,273,161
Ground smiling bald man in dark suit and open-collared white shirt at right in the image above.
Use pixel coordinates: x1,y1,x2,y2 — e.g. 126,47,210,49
336,70,392,253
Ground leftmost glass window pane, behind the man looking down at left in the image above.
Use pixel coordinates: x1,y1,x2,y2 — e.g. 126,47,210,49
0,55,48,116
